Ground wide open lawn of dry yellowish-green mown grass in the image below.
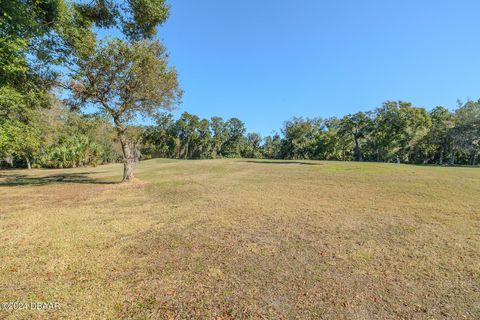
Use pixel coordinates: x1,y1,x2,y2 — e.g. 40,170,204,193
0,160,480,319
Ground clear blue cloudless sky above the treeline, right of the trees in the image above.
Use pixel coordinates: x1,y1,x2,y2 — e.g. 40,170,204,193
159,0,480,135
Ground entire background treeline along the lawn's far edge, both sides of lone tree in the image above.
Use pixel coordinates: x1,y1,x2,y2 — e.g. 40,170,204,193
0,100,480,168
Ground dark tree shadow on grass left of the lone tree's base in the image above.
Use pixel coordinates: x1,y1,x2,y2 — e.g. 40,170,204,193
0,172,118,187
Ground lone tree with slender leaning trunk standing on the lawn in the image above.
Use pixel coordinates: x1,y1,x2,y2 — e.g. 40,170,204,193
71,39,182,182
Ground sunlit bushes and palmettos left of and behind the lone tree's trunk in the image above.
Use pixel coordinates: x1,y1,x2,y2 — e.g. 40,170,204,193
0,103,119,168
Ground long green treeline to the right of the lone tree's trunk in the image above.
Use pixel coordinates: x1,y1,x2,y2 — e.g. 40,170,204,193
141,100,480,165
